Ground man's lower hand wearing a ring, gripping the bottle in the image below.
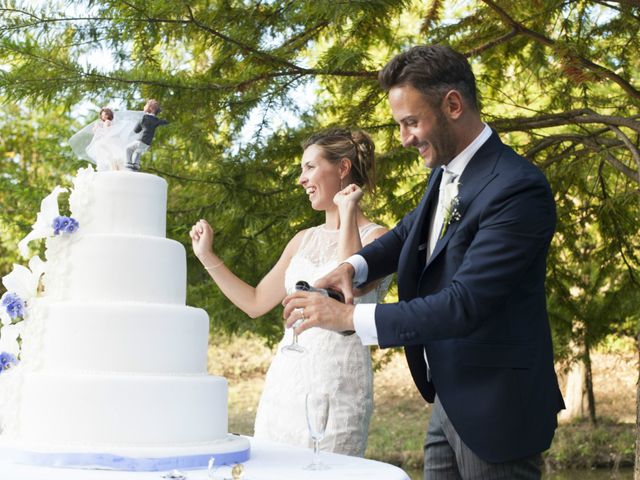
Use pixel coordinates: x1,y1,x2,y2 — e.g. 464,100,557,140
282,292,355,334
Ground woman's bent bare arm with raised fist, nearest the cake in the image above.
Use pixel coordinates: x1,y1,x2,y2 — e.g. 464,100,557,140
189,220,304,318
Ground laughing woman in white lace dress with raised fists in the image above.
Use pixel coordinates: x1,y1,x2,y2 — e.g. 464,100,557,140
190,129,388,456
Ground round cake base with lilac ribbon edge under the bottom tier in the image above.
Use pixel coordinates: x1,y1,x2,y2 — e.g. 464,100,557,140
0,434,250,472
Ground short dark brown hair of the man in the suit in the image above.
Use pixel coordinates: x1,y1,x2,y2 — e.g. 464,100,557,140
378,45,479,110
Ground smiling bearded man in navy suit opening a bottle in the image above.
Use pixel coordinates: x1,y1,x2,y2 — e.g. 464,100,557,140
284,45,564,480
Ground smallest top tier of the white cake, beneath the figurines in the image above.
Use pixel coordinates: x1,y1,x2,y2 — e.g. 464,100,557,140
71,171,167,237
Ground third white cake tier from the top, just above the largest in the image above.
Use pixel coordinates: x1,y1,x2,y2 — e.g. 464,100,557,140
43,302,209,375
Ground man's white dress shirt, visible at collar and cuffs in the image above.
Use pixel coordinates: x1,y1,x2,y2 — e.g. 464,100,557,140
345,124,491,345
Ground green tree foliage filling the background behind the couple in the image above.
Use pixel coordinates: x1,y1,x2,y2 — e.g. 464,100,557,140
0,0,640,348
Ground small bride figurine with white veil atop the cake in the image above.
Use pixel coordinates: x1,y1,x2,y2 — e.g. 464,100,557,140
69,107,143,171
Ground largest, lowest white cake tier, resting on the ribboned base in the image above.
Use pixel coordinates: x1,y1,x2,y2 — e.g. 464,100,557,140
20,373,227,447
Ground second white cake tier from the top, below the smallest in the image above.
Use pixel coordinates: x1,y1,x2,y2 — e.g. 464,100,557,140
45,235,187,305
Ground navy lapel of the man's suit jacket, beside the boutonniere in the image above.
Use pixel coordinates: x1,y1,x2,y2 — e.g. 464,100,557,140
425,131,504,268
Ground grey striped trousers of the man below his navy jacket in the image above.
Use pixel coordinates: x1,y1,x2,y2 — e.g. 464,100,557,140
424,396,542,480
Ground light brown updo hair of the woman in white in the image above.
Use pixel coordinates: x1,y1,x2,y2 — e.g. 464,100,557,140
302,128,375,191
